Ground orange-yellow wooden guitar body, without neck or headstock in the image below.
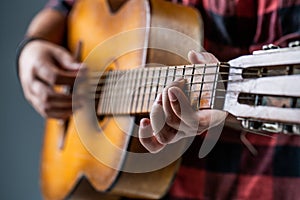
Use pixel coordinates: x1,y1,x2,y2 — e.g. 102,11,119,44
41,0,202,200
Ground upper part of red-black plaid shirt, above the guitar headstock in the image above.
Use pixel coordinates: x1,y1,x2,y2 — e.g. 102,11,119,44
185,0,300,61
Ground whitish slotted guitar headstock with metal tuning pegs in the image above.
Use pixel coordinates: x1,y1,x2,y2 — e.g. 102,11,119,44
224,46,300,135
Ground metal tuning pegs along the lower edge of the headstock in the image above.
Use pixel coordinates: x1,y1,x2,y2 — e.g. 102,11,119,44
238,118,300,135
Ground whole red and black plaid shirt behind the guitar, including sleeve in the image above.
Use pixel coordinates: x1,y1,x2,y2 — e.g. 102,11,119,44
48,0,300,200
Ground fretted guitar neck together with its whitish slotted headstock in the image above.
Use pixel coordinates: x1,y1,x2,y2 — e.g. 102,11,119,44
89,49,300,134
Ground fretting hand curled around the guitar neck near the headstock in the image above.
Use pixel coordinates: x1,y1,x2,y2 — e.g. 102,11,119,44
139,52,227,153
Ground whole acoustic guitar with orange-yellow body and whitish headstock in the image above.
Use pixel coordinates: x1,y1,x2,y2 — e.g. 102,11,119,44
41,0,300,200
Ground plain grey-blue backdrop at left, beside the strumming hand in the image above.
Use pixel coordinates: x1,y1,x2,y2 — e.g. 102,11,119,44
0,0,46,200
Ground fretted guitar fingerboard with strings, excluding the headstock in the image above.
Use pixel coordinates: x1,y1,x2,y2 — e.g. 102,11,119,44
97,63,225,115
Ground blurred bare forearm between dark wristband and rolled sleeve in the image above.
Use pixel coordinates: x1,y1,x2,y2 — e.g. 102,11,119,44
26,8,67,44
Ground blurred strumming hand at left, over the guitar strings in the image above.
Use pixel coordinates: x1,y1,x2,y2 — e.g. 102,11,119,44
19,40,80,119
